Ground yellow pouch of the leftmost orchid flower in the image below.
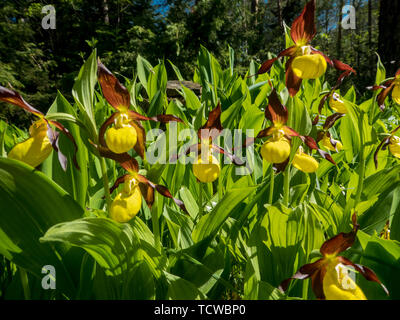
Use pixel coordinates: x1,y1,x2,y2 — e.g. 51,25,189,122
8,119,52,167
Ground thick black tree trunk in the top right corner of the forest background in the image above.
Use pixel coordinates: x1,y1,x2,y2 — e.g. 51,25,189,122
378,0,400,77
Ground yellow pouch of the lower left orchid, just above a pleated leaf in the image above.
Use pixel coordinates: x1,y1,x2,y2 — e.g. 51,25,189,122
110,178,142,223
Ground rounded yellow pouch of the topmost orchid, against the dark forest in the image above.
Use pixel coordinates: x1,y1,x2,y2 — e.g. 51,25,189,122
292,54,327,79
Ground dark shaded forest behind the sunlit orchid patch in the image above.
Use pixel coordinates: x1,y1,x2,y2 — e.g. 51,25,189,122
0,0,400,123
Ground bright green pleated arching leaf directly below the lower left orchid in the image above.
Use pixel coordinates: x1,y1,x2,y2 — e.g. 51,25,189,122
40,217,162,275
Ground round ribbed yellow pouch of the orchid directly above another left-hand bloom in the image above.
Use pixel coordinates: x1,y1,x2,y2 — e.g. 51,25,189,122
106,113,137,154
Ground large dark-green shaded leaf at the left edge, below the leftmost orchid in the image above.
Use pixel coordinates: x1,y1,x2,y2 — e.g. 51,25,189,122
0,158,83,294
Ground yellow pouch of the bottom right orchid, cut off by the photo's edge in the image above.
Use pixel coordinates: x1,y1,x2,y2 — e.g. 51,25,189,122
323,259,367,300
